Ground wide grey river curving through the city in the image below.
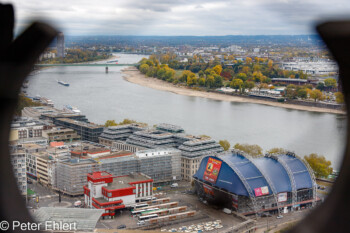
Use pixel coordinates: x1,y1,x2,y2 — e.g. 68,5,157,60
27,54,346,168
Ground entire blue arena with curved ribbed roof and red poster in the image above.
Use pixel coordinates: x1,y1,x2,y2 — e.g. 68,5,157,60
194,151,317,214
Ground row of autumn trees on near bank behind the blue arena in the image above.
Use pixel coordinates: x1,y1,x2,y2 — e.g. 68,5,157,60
219,140,333,178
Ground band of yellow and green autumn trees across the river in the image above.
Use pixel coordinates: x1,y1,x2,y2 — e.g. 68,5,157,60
138,54,344,103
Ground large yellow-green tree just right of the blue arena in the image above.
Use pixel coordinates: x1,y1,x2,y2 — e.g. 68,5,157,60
304,153,333,178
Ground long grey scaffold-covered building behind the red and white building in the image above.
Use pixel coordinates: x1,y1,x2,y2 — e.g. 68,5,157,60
52,148,181,196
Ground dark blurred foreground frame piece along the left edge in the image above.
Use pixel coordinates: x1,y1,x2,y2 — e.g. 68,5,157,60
0,4,57,232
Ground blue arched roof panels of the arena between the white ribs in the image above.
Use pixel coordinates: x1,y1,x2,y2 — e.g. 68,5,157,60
194,152,312,196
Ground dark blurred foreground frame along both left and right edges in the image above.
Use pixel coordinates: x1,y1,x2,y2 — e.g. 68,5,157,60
0,4,350,233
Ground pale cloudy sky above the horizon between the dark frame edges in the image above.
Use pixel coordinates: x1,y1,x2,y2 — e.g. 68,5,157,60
1,0,350,36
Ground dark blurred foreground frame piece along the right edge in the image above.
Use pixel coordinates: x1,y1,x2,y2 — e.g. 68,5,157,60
290,21,350,233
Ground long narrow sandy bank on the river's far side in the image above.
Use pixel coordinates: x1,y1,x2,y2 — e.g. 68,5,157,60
122,67,345,114
